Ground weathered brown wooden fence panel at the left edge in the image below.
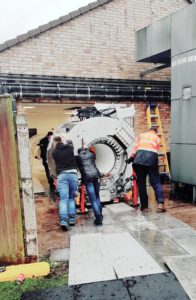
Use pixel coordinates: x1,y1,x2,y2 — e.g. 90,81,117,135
0,96,24,262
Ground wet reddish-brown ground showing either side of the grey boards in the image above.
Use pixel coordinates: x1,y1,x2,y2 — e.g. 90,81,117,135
35,185,196,257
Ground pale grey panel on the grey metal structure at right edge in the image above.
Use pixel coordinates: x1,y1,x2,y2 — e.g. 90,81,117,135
171,49,196,100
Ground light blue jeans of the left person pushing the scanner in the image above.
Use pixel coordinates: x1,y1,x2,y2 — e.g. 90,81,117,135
57,172,78,221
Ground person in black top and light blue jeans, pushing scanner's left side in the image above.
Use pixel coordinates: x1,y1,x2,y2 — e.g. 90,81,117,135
52,136,78,230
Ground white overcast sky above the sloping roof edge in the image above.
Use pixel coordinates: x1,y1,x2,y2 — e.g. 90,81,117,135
0,0,92,44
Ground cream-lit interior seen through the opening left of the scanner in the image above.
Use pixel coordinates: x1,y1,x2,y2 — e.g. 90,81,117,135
22,103,84,193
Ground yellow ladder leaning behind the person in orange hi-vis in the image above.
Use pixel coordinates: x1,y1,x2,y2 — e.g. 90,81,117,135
146,104,170,178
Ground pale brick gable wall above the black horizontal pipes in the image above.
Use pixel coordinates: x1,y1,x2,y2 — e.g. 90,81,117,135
0,0,189,79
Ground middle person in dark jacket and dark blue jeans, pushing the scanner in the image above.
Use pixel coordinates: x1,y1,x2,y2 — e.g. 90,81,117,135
76,148,103,226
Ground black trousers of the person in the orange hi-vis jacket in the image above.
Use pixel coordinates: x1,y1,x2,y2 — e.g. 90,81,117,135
133,164,164,209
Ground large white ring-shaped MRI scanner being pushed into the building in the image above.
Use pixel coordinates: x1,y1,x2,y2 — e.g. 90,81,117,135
48,105,135,202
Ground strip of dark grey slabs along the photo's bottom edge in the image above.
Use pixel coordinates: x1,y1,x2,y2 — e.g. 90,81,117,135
21,273,189,300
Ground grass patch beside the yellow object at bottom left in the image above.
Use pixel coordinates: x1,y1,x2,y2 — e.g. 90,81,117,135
0,262,68,300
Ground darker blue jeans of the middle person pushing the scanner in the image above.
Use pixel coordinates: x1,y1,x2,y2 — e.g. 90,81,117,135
85,178,103,221
